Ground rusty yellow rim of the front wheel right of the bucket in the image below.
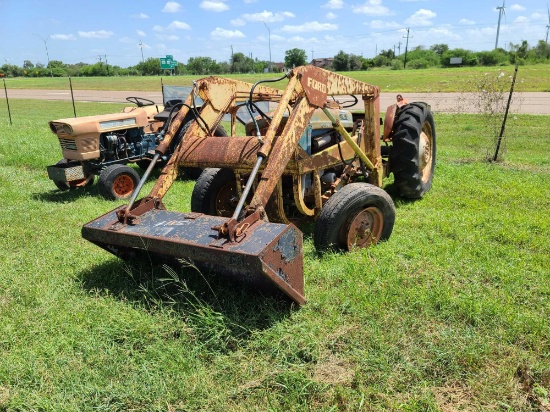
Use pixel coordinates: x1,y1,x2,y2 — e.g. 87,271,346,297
340,206,384,249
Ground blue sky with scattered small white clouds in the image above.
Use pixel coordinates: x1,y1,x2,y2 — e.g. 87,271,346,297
0,0,550,67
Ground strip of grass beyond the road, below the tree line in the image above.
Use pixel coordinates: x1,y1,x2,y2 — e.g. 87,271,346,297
6,64,550,93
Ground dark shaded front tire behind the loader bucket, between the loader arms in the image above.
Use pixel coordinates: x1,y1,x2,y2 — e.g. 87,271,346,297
191,168,239,217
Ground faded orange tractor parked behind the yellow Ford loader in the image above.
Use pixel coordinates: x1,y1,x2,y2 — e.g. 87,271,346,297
47,86,225,200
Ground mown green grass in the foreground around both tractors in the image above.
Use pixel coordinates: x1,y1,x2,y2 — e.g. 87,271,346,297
0,100,550,411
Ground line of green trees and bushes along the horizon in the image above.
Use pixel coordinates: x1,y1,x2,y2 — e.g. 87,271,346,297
0,40,550,77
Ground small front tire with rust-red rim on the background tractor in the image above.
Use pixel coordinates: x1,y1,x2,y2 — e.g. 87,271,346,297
97,165,139,200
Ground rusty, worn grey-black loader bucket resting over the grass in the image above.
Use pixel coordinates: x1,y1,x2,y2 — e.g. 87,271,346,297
82,206,305,304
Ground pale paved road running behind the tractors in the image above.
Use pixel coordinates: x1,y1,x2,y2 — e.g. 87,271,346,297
8,89,550,114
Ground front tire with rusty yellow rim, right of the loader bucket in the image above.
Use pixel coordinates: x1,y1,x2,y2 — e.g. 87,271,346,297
313,183,395,251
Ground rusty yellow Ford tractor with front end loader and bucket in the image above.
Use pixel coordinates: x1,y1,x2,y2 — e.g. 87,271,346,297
82,66,435,304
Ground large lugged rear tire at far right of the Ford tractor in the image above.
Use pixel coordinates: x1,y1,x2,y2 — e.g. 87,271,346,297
390,103,436,199
